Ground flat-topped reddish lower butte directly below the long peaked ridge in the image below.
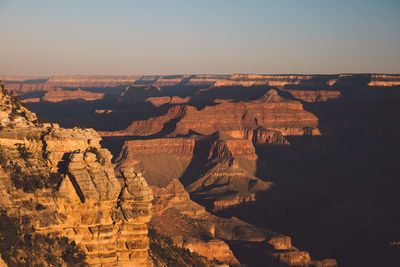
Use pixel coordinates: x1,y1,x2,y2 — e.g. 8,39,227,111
116,134,272,210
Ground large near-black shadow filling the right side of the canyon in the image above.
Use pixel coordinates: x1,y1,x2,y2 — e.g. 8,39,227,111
219,87,400,267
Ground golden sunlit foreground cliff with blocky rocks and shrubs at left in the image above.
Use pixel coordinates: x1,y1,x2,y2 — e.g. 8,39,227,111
0,85,152,266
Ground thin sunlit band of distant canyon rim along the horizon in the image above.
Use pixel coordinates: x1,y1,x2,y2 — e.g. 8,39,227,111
0,74,400,97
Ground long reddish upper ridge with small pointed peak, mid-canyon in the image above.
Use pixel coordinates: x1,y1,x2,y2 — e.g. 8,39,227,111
101,90,320,136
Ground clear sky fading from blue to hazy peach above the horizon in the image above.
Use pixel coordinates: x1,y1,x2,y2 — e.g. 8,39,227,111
0,0,400,75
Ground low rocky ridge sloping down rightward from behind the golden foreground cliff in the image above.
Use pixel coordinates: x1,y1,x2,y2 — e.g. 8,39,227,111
150,180,337,267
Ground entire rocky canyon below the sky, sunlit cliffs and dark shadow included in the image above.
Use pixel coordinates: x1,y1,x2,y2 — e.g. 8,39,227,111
0,74,400,267
